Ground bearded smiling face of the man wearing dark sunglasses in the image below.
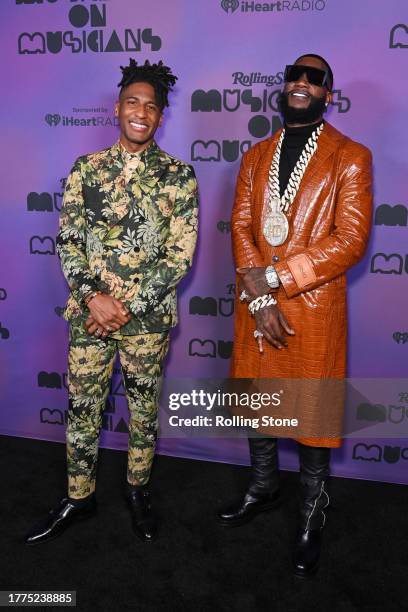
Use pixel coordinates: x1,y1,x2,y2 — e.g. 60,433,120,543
281,55,332,126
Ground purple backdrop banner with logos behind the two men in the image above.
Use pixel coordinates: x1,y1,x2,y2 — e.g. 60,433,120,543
0,0,408,483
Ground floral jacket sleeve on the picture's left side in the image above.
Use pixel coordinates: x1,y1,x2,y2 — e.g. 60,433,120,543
56,159,98,301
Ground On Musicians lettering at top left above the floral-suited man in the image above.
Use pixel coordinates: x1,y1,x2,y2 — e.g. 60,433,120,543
16,0,162,55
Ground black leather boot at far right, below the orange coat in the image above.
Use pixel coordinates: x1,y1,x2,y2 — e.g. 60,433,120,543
293,444,330,578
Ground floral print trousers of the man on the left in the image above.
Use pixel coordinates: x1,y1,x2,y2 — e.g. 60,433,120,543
66,324,169,499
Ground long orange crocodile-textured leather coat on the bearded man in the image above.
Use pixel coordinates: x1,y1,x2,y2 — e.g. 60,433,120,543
231,123,372,447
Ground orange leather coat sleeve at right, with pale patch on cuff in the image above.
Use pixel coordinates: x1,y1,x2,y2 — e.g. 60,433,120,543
275,143,372,298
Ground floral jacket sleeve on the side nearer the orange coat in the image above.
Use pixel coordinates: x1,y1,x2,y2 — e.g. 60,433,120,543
129,166,198,316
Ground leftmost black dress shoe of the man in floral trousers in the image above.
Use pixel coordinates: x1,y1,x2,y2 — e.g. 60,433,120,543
25,495,96,546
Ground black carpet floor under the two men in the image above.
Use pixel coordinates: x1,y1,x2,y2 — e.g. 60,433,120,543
0,436,408,612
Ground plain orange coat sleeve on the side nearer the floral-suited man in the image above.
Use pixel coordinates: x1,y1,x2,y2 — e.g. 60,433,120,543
231,149,266,268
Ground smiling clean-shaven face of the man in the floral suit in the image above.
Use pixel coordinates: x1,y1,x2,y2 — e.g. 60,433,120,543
115,82,163,153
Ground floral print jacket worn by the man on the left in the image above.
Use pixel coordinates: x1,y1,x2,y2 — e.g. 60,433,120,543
57,142,198,335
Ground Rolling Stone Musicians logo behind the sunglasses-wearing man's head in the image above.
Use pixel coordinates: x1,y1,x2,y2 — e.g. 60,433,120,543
191,86,351,162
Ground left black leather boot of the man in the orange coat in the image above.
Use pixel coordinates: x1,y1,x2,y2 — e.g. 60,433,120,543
217,437,279,527
